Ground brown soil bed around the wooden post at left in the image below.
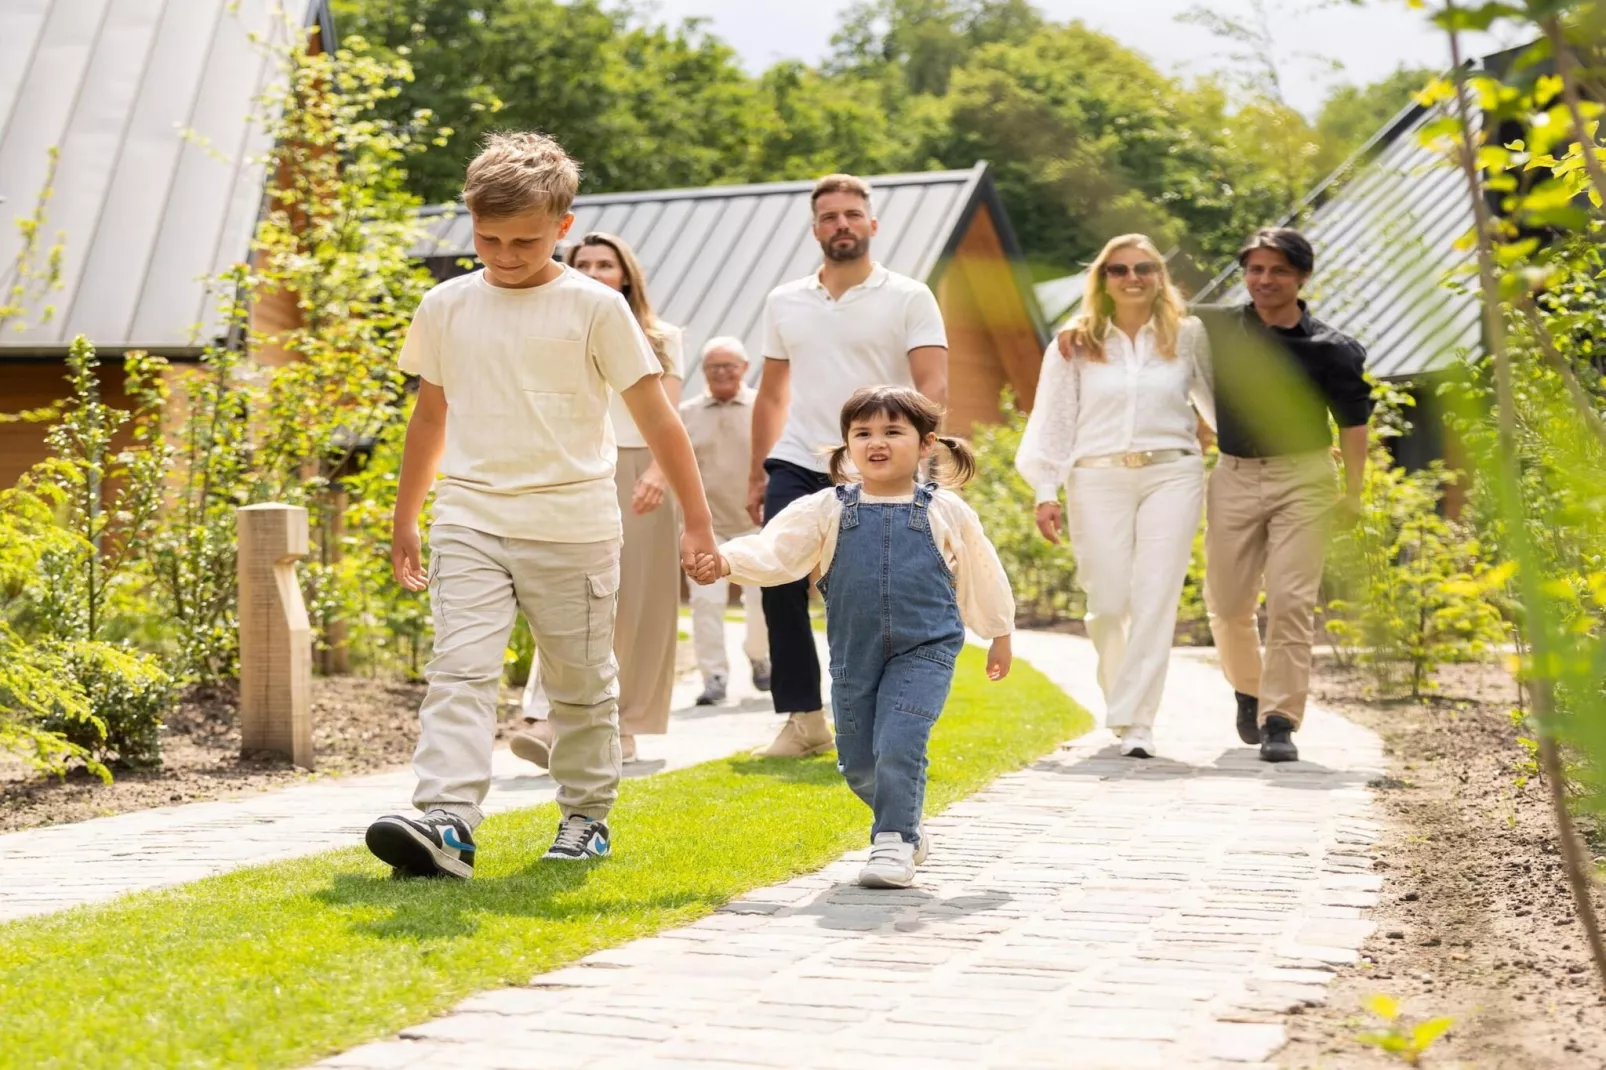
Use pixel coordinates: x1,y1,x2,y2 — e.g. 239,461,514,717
0,676,481,832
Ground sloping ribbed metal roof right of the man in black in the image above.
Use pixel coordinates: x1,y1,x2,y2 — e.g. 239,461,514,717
1198,93,1482,379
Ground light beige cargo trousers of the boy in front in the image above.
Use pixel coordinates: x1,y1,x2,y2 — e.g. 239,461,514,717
413,524,620,826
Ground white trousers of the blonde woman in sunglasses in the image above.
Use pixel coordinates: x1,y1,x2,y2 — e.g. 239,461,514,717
1065,456,1205,728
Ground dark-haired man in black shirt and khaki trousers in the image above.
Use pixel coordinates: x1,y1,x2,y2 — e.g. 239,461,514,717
1198,228,1372,762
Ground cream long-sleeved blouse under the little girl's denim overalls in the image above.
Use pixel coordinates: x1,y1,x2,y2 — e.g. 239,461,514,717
719,488,1015,639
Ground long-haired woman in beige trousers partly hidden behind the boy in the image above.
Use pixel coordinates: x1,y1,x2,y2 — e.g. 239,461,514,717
511,231,686,766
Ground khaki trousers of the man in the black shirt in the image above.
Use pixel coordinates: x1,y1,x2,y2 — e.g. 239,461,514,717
1205,451,1338,728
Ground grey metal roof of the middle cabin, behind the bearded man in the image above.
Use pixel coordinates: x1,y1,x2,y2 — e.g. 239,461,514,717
413,162,1046,374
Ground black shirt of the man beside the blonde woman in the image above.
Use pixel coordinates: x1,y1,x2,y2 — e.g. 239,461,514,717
1195,300,1372,456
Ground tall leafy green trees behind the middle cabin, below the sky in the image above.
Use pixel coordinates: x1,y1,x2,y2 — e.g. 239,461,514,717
337,0,1426,276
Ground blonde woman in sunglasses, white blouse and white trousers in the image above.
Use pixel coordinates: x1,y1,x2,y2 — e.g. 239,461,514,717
1015,235,1216,758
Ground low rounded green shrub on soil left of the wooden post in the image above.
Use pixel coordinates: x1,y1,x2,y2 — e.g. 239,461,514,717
40,641,175,768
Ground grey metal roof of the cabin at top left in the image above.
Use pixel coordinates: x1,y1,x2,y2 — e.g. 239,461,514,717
0,0,334,357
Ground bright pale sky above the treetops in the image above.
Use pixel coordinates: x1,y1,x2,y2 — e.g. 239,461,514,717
654,0,1518,114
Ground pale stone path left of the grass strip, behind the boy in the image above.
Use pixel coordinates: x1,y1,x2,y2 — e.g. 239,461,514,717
0,623,799,922
